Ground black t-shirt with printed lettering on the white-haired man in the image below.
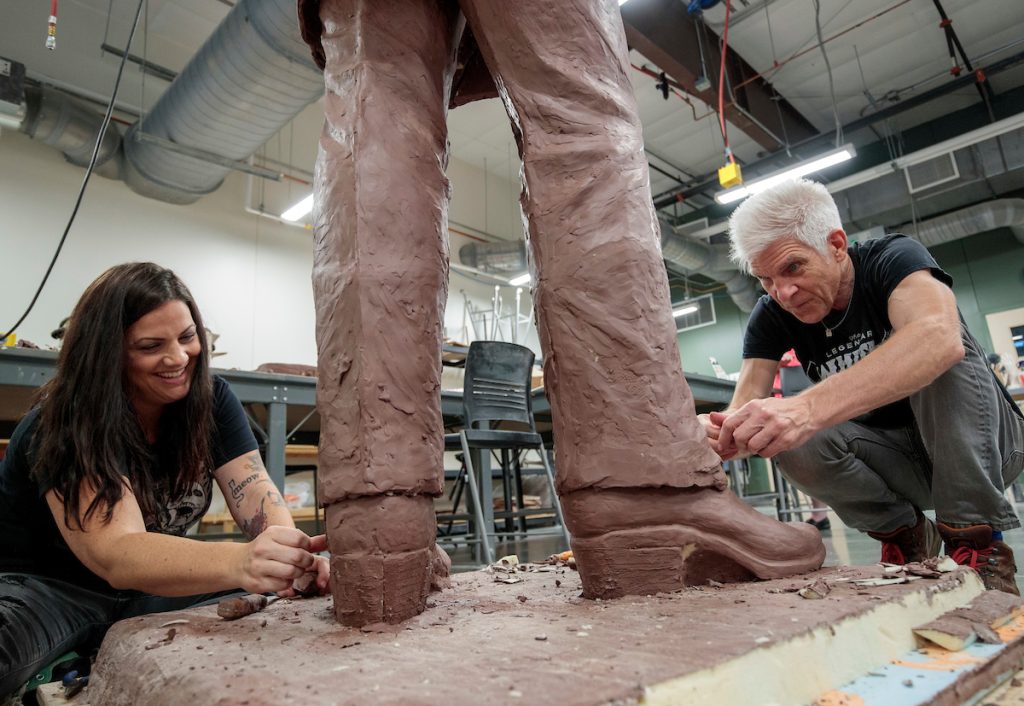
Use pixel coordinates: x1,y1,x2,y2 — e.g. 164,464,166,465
743,235,953,428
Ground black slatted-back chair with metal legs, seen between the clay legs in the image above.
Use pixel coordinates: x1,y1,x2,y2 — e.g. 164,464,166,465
444,341,569,564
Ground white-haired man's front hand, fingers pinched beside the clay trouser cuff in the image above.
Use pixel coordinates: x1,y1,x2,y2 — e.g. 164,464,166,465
709,394,818,461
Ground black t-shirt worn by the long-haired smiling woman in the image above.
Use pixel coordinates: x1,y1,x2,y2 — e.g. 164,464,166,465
0,376,257,592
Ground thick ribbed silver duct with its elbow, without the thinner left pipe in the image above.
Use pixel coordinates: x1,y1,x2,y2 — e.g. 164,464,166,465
124,0,324,204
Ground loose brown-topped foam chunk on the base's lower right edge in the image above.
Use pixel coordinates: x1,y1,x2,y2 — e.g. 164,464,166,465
913,591,1024,652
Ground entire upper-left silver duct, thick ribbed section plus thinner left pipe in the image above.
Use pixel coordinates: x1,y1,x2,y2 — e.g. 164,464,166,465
14,0,324,204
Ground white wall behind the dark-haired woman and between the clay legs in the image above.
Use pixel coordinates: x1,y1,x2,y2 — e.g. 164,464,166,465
0,131,537,369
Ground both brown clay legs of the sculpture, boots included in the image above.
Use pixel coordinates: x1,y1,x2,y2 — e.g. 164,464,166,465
313,0,824,625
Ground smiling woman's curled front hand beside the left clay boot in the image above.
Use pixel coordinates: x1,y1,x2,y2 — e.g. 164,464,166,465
237,525,319,595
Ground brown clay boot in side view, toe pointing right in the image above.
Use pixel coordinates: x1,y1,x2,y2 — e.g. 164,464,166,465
561,488,825,598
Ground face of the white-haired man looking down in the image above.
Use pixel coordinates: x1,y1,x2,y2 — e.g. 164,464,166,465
751,231,847,324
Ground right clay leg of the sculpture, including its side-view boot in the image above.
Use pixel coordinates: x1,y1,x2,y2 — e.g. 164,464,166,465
460,0,824,596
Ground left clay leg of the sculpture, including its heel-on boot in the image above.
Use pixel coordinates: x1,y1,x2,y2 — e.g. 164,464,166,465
313,0,461,625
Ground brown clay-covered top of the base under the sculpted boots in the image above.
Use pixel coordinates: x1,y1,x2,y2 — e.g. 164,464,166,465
88,565,959,706
